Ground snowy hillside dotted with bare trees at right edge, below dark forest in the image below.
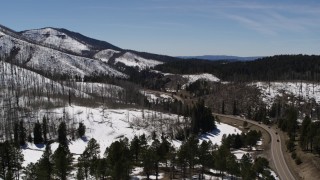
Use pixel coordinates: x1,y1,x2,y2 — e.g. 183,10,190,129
250,81,320,105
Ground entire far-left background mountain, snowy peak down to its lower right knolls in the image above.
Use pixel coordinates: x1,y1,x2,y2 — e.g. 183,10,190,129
20,28,162,70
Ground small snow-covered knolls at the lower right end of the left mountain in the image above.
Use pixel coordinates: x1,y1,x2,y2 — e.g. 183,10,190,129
115,52,162,70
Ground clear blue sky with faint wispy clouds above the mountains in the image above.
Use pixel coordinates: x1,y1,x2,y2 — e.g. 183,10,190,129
0,0,320,56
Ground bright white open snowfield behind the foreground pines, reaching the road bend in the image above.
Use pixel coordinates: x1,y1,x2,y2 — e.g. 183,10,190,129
23,106,241,166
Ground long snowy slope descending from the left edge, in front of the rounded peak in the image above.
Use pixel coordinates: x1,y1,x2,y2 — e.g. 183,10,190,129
0,28,126,78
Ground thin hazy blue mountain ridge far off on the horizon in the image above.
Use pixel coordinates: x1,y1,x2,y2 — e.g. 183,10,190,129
178,55,264,61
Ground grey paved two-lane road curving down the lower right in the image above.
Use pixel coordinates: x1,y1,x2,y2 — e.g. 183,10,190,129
218,114,295,180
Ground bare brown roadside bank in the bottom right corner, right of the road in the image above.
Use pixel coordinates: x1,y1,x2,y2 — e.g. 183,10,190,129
279,132,320,180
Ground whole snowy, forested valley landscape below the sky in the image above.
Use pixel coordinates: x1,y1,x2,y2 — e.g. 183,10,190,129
0,23,320,179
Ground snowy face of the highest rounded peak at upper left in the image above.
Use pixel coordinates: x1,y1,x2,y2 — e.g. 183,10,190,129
22,28,90,54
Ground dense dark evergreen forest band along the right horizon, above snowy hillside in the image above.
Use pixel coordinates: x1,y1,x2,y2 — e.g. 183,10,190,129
155,55,320,81
